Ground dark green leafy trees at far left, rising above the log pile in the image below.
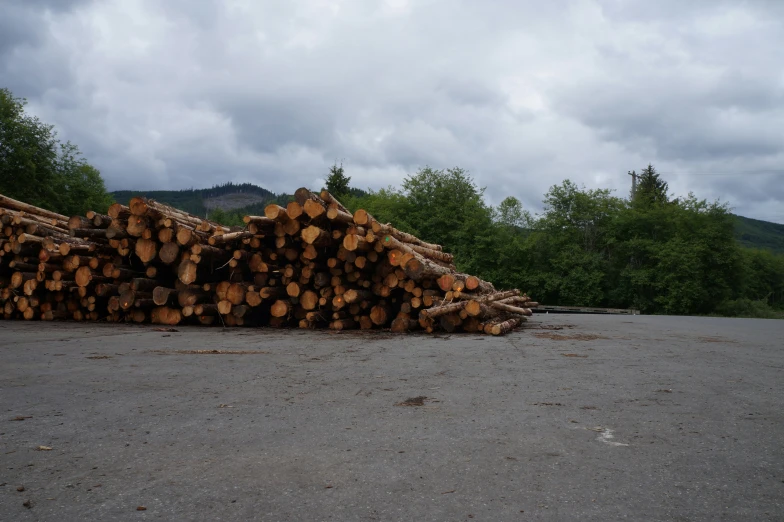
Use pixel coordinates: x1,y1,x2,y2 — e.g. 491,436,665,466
0,89,113,215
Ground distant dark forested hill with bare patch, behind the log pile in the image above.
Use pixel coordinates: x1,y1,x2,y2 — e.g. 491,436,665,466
111,182,290,216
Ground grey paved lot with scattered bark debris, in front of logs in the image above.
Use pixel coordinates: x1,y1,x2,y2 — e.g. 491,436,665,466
0,315,784,521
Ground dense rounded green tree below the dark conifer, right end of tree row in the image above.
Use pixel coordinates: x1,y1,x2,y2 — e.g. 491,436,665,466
610,194,739,314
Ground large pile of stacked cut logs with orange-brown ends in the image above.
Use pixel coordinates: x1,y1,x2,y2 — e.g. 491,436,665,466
0,189,537,335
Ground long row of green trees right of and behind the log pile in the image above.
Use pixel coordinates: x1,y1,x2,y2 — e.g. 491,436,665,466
327,165,784,317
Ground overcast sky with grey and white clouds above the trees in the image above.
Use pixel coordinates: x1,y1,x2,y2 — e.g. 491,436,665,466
0,0,784,223
